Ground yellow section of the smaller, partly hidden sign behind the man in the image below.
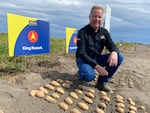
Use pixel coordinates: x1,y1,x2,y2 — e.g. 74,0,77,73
66,27,76,53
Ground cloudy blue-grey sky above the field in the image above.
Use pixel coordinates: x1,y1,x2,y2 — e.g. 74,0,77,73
0,0,150,44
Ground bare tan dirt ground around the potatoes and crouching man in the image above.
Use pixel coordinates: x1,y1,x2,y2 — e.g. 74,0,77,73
0,44,150,113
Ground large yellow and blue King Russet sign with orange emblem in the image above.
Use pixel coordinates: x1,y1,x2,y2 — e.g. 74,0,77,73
7,13,50,57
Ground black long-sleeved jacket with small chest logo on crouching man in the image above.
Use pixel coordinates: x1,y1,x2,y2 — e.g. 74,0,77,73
76,24,119,68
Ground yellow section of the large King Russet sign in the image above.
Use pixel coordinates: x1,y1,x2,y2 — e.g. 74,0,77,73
7,13,37,56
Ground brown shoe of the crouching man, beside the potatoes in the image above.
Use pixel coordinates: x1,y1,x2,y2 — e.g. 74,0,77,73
95,82,113,92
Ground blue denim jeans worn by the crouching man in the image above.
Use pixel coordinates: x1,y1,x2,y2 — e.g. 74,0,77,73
76,53,124,83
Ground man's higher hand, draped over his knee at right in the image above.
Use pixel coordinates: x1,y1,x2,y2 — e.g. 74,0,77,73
107,51,118,67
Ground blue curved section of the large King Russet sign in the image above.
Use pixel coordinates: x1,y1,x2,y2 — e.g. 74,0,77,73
14,20,50,56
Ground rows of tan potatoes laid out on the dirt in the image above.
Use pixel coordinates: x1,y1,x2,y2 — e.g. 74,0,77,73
29,79,147,113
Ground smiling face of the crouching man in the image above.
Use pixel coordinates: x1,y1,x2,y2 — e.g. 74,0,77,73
89,9,103,30
